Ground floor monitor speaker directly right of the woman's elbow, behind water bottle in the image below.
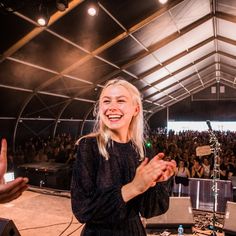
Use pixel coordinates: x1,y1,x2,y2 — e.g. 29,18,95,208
146,197,194,233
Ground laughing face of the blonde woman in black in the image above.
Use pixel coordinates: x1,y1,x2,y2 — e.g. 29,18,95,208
99,85,139,135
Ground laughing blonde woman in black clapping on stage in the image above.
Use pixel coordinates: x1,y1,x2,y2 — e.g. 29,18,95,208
71,79,176,236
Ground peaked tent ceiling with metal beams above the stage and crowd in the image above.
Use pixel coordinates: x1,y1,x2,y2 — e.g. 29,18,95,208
0,0,236,124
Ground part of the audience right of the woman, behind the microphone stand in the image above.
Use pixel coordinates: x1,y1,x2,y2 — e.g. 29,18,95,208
148,129,236,180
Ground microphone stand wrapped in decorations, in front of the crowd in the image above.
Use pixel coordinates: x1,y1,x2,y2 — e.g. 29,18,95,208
206,120,220,236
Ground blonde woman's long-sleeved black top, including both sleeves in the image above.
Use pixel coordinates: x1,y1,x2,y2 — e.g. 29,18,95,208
71,137,170,236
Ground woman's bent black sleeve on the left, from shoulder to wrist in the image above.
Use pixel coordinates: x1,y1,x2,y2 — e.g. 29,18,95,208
71,140,126,223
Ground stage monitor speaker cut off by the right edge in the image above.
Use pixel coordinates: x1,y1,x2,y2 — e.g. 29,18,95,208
223,201,236,235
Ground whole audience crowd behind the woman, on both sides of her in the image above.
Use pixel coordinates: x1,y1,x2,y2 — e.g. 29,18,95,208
5,128,236,180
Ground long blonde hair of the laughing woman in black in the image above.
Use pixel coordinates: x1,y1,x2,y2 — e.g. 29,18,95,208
82,78,144,160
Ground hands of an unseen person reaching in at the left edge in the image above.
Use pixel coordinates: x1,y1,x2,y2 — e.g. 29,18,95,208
0,139,28,203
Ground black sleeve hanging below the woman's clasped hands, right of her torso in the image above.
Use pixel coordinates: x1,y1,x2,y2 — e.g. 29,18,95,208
140,177,173,218
